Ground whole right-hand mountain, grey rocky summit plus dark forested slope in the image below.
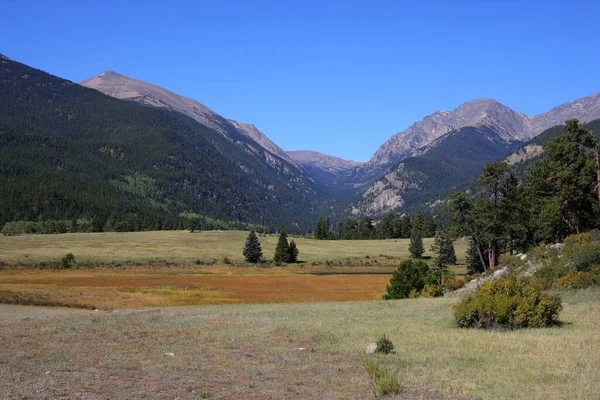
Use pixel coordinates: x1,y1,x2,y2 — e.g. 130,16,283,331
351,93,600,219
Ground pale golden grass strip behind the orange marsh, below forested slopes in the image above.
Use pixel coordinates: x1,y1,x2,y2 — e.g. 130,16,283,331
0,231,465,265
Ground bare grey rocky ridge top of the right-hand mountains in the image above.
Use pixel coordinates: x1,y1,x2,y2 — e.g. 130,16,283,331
358,93,600,182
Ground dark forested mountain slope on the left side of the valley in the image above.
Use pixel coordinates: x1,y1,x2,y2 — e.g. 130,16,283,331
0,56,320,231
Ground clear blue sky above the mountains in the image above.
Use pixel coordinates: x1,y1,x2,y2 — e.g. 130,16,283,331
0,0,600,160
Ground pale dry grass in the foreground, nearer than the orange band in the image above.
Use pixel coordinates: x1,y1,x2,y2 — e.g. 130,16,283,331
0,290,600,399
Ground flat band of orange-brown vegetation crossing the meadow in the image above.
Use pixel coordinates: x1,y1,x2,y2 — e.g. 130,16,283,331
0,270,390,309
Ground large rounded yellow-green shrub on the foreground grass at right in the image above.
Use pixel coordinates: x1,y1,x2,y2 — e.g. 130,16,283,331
454,275,562,329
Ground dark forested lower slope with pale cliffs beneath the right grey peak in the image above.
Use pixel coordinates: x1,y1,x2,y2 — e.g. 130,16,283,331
351,126,522,216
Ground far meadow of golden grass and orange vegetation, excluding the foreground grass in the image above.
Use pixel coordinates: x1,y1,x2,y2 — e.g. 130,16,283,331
0,231,464,310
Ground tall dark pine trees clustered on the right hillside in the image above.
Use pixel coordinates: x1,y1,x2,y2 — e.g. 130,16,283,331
446,119,600,273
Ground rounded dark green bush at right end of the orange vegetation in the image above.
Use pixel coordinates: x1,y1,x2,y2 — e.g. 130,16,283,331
383,259,429,300
